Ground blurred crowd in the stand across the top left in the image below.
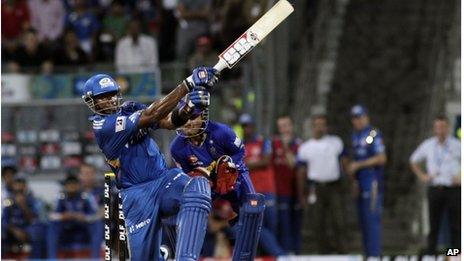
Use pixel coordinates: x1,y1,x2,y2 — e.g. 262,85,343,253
1,0,267,73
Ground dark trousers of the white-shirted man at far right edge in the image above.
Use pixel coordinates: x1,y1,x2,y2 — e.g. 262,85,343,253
427,186,461,254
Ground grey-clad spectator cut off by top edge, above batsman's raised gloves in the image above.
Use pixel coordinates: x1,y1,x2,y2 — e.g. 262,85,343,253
176,0,211,61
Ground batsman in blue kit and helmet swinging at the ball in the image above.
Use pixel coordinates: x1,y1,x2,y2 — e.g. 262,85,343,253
82,67,218,261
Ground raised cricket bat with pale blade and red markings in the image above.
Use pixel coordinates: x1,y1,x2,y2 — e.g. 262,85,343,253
214,0,294,72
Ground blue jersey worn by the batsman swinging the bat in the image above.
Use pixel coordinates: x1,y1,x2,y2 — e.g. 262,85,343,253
91,102,167,188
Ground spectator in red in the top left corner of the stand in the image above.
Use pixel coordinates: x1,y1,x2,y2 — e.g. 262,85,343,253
2,0,30,41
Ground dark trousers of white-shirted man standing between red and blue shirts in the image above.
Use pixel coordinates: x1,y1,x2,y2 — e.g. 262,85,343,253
310,181,346,254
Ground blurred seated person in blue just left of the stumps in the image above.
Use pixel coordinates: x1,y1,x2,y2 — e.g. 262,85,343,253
47,175,100,258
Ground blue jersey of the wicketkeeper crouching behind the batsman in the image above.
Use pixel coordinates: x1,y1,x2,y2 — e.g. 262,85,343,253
171,121,254,194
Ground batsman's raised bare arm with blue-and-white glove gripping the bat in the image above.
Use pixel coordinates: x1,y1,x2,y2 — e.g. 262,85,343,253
138,67,218,129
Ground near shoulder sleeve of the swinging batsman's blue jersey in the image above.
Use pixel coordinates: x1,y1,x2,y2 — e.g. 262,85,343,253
99,111,141,160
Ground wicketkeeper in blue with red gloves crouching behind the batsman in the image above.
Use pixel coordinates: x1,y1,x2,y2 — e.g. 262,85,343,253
170,105,265,261
